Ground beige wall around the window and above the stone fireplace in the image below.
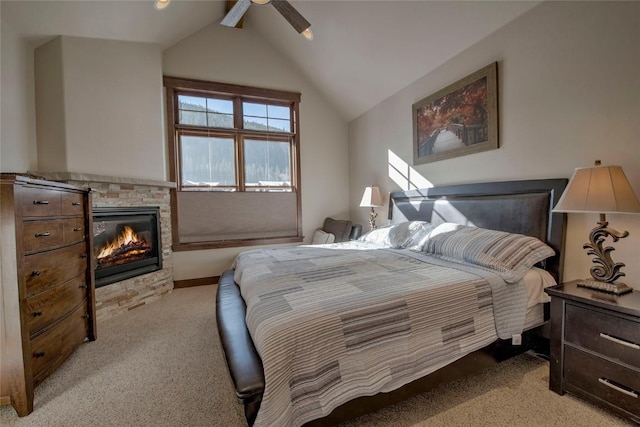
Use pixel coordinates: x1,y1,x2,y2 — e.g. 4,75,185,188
2,23,349,280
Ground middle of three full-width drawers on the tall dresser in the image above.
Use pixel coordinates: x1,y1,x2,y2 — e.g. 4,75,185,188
26,274,87,337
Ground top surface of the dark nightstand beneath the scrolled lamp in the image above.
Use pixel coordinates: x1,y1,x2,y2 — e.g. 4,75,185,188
545,280,640,317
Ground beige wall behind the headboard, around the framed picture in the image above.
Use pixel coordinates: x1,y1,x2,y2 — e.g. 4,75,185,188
349,2,640,289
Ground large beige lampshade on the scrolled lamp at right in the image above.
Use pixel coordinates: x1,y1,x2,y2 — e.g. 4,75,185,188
553,166,640,214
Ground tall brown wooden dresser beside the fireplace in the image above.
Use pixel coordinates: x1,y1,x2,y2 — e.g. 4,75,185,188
0,174,96,416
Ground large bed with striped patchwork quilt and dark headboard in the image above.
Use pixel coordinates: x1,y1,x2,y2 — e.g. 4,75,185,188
216,179,567,426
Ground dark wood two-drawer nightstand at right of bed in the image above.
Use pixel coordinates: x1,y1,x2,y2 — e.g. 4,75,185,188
545,281,640,423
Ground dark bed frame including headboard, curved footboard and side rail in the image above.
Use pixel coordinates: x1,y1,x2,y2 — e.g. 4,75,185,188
216,179,567,426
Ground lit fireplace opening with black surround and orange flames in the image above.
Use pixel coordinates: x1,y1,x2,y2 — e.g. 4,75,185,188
93,206,162,288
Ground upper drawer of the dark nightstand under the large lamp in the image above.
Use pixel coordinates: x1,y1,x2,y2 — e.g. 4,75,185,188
565,304,640,370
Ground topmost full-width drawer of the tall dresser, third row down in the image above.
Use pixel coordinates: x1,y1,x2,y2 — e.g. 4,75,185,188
22,242,87,297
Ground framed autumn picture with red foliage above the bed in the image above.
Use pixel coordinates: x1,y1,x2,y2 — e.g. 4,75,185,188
413,62,498,165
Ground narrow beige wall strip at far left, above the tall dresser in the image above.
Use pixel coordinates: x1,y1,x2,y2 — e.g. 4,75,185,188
0,20,37,172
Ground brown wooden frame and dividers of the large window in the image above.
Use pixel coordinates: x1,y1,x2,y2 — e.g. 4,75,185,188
163,76,303,252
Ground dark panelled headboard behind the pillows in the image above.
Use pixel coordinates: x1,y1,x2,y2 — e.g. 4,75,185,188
389,178,568,283
